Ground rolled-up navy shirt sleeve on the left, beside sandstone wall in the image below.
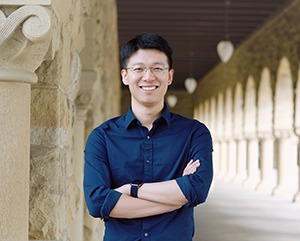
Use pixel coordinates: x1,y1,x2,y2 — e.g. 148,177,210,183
83,128,121,220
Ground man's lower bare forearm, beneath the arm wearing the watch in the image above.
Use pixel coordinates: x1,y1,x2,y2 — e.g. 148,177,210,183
109,194,181,219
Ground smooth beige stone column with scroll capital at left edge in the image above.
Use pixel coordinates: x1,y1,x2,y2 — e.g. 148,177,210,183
0,1,51,241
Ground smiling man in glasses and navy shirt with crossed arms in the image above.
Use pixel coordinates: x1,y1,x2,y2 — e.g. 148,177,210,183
84,34,213,241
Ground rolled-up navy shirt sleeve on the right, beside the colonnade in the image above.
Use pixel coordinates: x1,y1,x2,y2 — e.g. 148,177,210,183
176,123,213,207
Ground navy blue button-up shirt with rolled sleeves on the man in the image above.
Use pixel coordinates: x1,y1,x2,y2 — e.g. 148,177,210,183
84,104,213,241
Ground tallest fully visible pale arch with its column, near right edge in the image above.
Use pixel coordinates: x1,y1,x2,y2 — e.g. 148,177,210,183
273,57,298,196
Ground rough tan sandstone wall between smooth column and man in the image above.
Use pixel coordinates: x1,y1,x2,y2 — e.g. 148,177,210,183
29,0,120,241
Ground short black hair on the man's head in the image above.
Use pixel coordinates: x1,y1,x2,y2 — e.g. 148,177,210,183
121,33,173,69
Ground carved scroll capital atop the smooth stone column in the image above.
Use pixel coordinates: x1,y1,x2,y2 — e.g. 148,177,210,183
0,5,51,83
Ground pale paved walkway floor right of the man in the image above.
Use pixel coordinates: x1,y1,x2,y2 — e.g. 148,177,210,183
194,179,300,241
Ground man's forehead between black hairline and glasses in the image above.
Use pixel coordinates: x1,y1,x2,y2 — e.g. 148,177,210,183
128,49,168,66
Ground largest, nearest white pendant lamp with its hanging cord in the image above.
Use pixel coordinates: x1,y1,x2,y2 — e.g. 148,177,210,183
217,0,234,63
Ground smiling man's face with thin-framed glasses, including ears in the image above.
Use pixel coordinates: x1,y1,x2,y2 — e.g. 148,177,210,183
121,49,174,107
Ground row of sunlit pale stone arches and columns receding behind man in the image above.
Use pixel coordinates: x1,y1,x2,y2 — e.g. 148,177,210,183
195,57,300,202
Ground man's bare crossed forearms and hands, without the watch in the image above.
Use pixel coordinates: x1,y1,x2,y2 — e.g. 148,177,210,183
110,160,200,218
